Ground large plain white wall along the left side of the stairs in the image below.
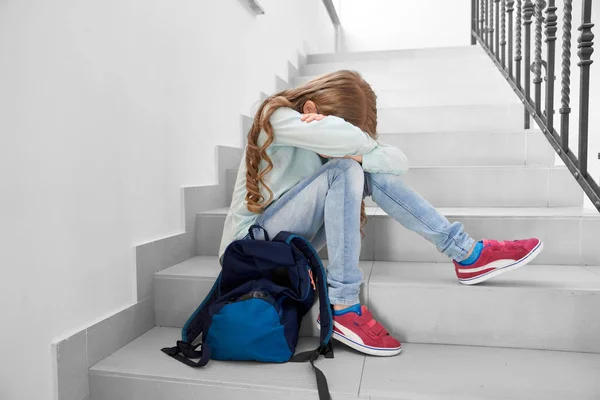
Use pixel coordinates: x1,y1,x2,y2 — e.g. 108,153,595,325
0,0,334,400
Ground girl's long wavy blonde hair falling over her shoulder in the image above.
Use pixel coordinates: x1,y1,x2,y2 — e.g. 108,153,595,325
245,70,377,234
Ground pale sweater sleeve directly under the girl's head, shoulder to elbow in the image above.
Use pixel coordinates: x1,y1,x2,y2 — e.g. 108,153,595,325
268,107,377,157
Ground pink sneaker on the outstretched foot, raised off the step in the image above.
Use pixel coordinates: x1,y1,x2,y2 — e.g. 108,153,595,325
454,239,544,285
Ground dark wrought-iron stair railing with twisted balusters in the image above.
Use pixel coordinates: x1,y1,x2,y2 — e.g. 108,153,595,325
471,0,600,211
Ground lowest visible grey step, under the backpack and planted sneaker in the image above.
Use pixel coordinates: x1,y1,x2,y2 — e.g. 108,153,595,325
89,328,600,400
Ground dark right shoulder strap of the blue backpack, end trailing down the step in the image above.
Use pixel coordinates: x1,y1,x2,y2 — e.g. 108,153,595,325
273,232,333,400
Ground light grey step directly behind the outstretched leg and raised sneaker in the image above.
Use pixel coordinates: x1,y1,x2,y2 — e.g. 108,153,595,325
196,207,600,265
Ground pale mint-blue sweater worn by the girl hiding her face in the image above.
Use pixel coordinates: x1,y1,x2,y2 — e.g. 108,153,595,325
219,107,408,257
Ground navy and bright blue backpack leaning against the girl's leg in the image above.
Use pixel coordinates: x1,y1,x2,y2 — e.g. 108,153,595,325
162,225,333,400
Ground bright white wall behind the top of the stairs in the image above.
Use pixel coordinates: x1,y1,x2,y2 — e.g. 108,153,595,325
336,0,471,51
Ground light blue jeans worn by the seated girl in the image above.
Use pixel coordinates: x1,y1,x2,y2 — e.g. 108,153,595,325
257,158,475,305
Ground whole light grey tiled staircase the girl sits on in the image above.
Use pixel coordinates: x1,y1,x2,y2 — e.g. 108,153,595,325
89,46,600,400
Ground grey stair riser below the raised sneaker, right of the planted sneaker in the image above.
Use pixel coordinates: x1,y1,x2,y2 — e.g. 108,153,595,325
369,282,600,353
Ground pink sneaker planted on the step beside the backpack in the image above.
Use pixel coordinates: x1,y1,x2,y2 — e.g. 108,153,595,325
317,305,402,357
